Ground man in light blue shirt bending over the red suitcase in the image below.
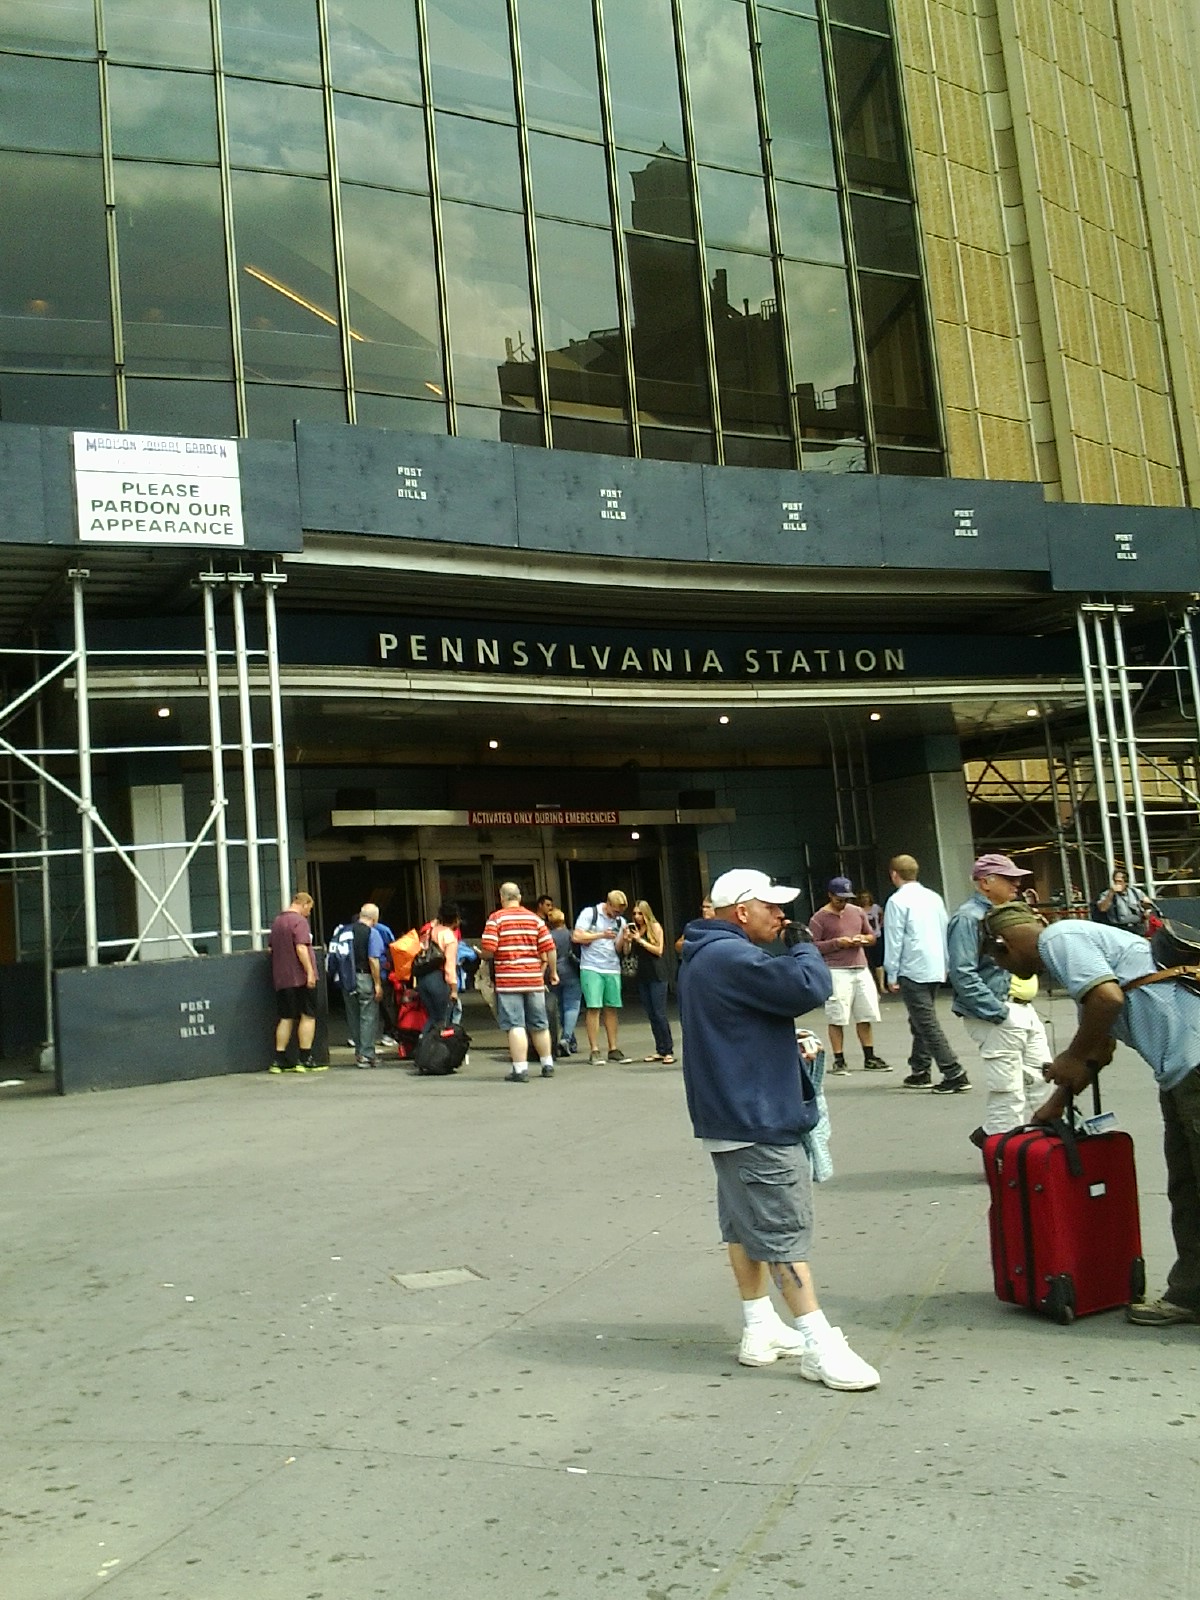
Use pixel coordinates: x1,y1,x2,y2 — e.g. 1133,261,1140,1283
984,904,1200,1328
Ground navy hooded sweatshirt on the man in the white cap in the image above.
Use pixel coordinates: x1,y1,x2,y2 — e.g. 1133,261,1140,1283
678,918,834,1144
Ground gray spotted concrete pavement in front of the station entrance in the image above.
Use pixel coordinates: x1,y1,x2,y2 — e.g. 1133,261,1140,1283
0,1000,1200,1600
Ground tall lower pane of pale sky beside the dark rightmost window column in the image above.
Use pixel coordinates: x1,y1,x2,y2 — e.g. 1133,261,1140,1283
782,261,862,435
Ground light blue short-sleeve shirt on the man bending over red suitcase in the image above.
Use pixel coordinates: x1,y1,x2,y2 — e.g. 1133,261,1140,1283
1037,922,1200,1090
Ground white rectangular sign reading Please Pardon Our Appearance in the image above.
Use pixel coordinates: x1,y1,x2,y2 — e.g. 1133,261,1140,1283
72,434,246,546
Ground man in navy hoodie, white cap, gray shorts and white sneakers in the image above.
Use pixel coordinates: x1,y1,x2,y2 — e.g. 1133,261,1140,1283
678,867,878,1389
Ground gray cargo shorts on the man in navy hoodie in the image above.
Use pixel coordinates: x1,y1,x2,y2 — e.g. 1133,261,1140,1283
712,1144,813,1261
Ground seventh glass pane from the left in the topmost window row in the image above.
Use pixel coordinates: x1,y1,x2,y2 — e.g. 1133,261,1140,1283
603,0,683,155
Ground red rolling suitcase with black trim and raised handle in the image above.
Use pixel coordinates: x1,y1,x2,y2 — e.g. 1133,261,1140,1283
984,1112,1146,1323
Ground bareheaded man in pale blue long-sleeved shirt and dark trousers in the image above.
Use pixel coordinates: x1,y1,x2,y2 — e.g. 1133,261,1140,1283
883,856,971,1094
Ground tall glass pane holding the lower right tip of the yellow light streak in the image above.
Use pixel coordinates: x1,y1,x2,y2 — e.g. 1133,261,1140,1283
342,184,445,397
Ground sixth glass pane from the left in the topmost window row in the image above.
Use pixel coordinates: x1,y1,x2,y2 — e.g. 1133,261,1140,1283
517,0,600,138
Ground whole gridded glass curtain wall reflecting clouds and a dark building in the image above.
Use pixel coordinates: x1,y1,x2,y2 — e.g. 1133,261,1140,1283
0,0,942,474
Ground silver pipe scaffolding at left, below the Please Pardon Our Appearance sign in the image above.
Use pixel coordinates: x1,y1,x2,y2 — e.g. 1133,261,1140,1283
0,563,293,1049
